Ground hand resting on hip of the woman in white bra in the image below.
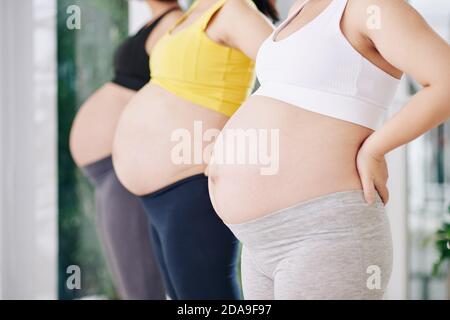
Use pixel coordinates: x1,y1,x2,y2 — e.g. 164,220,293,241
356,143,389,204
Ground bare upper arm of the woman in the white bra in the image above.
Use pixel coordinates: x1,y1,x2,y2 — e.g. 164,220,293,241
356,0,450,86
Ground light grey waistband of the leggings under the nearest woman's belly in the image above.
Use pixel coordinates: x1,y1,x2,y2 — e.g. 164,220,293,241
227,190,387,249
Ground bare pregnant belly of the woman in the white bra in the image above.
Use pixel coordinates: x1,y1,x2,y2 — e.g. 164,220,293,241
208,96,372,224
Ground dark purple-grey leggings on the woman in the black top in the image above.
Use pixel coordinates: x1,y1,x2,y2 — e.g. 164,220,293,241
82,157,165,300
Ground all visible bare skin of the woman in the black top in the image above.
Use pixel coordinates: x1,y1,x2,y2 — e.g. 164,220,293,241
70,0,182,167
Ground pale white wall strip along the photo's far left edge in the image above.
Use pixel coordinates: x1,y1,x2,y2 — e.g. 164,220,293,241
0,0,57,299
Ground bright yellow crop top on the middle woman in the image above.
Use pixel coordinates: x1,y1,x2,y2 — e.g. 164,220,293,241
150,0,255,116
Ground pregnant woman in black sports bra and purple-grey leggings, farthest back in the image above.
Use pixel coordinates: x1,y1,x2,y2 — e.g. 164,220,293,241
70,0,181,299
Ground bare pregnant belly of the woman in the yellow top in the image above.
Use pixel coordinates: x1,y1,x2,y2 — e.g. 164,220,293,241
113,83,228,195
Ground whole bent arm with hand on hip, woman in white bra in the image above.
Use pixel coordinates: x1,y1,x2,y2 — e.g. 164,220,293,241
350,0,450,203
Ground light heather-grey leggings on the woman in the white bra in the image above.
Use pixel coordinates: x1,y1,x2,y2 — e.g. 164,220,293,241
228,190,392,300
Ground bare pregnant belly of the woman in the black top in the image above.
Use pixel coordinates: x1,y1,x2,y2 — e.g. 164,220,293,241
70,83,135,166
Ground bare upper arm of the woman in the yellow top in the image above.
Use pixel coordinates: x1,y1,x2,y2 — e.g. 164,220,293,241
222,0,273,60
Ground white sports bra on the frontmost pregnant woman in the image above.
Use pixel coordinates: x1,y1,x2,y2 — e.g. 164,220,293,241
254,0,400,130
